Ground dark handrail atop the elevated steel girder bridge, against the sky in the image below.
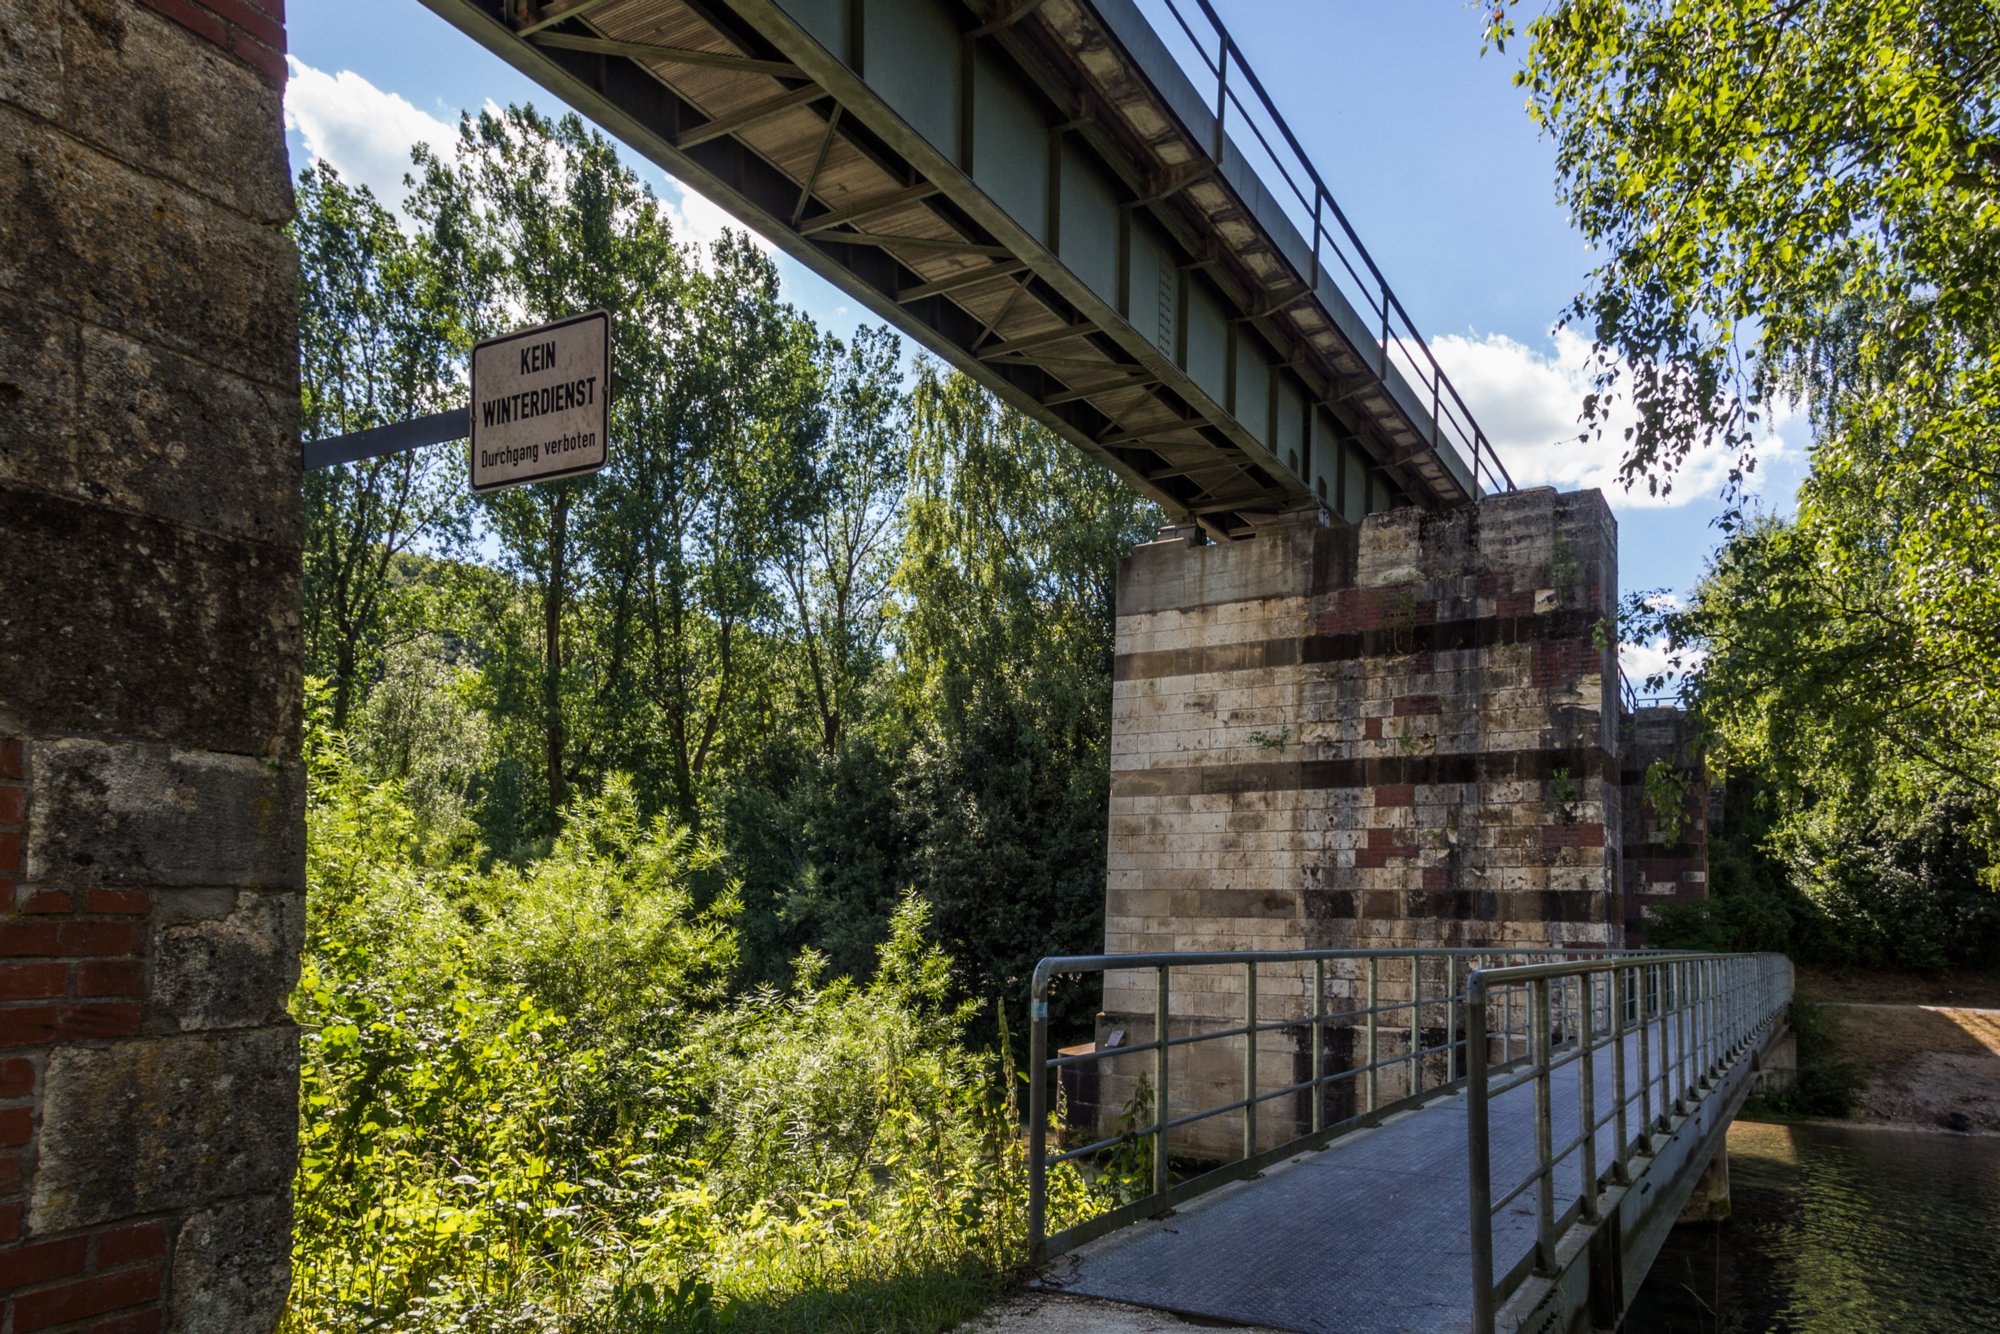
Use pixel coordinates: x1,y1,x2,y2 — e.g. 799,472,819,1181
1158,0,1514,492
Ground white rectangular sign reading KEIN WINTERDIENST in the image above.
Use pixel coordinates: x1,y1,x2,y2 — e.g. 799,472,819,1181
472,310,612,490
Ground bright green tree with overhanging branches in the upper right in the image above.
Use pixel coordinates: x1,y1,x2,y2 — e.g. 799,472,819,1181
1492,0,2000,806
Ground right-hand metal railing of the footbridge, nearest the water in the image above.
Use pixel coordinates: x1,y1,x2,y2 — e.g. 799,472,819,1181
1464,954,1792,1332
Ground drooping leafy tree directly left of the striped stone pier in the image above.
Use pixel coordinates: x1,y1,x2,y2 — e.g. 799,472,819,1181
892,364,1160,998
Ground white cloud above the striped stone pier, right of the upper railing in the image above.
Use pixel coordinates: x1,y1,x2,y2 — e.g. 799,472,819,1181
1430,328,1800,510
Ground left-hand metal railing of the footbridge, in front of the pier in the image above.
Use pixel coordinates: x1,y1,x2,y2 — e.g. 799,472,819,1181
1028,948,1656,1260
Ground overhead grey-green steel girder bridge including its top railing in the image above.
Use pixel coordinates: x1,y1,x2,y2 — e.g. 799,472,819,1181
424,0,1512,538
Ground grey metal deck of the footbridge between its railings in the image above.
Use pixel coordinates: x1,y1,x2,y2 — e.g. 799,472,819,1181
1042,1026,1660,1334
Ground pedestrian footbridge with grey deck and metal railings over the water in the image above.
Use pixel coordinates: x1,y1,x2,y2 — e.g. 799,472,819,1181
1030,950,1792,1334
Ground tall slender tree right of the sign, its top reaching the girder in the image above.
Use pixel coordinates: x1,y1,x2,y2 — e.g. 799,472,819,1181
590,232,826,826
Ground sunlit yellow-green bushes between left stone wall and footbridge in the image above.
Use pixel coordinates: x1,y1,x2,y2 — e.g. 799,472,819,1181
284,728,1104,1334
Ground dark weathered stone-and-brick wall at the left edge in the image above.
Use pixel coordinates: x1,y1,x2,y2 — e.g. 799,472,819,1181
0,0,304,1334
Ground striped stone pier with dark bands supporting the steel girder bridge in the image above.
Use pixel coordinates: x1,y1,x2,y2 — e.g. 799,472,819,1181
1098,488,1626,1156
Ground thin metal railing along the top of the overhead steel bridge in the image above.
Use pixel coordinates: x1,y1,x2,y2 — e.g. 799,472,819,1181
1142,0,1514,490
